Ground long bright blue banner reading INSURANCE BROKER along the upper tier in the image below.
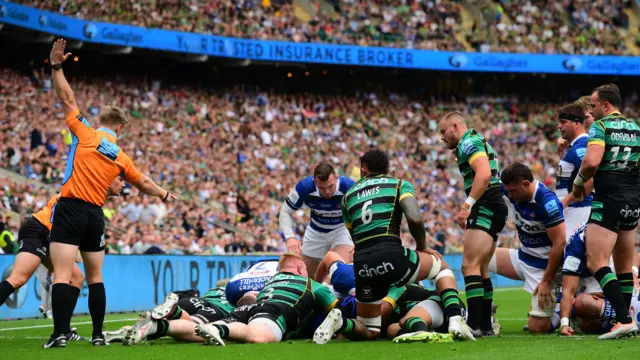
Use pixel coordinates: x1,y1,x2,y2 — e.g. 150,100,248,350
0,0,640,76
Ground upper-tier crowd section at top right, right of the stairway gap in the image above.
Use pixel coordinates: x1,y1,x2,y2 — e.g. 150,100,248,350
467,0,630,55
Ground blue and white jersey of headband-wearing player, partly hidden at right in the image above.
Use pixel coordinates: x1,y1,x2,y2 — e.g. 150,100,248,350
556,134,593,207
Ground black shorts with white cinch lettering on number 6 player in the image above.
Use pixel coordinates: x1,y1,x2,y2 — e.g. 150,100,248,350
353,239,420,303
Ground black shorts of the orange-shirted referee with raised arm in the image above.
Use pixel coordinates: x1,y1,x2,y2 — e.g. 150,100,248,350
49,198,105,252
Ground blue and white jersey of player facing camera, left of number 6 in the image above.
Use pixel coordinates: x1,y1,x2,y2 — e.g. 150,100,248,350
285,176,355,233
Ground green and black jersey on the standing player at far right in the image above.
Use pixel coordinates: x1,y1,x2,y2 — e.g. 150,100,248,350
589,113,640,193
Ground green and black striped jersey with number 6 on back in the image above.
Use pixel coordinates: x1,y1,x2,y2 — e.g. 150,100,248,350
342,175,416,245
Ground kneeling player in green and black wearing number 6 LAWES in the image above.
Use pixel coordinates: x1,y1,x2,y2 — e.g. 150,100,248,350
342,149,475,340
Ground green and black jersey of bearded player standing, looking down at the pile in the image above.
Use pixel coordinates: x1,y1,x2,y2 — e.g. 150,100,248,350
456,129,500,195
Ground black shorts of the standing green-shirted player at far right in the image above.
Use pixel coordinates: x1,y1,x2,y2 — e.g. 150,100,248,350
588,191,640,232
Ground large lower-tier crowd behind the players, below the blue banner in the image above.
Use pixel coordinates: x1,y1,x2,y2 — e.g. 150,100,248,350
0,66,640,254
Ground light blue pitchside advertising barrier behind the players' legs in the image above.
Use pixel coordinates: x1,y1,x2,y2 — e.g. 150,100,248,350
0,255,521,320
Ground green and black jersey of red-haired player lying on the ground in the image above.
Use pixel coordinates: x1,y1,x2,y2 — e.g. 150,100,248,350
258,272,338,321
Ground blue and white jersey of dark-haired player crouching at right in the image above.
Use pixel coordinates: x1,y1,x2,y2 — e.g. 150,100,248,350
501,181,564,269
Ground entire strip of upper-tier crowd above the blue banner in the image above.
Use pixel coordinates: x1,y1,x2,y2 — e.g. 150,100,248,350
18,0,629,55
